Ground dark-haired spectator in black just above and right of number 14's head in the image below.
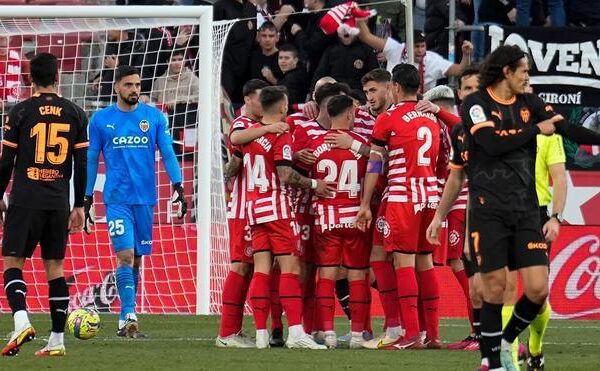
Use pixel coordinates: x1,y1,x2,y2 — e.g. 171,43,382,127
277,44,308,109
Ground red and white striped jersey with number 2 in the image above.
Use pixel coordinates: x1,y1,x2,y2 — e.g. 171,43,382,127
371,101,440,206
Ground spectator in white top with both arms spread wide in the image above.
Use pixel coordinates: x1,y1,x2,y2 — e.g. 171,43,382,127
358,22,473,94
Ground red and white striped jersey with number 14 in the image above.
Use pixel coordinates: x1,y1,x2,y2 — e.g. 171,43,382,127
242,123,294,225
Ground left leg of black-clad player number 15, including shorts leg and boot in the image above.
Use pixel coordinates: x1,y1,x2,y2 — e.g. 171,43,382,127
2,205,41,356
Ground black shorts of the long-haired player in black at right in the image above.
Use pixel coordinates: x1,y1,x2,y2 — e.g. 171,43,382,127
469,208,548,273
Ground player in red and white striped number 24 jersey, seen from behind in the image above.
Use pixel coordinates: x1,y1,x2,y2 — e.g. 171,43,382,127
310,95,370,348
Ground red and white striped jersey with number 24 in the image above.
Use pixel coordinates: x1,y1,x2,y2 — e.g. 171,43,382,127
311,130,367,231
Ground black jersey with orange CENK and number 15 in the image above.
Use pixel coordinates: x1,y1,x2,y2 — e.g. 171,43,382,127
0,93,88,210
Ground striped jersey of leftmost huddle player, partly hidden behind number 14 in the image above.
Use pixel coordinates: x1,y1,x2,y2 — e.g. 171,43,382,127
227,116,257,219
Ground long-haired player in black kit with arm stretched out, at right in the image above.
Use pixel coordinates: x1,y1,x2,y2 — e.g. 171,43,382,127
463,46,600,371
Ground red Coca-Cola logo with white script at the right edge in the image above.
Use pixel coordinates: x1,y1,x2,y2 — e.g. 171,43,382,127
550,235,600,319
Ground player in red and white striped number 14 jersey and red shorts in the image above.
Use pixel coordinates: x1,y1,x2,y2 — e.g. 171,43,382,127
242,87,332,349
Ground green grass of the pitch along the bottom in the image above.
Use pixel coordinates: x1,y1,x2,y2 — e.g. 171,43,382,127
0,314,600,371
